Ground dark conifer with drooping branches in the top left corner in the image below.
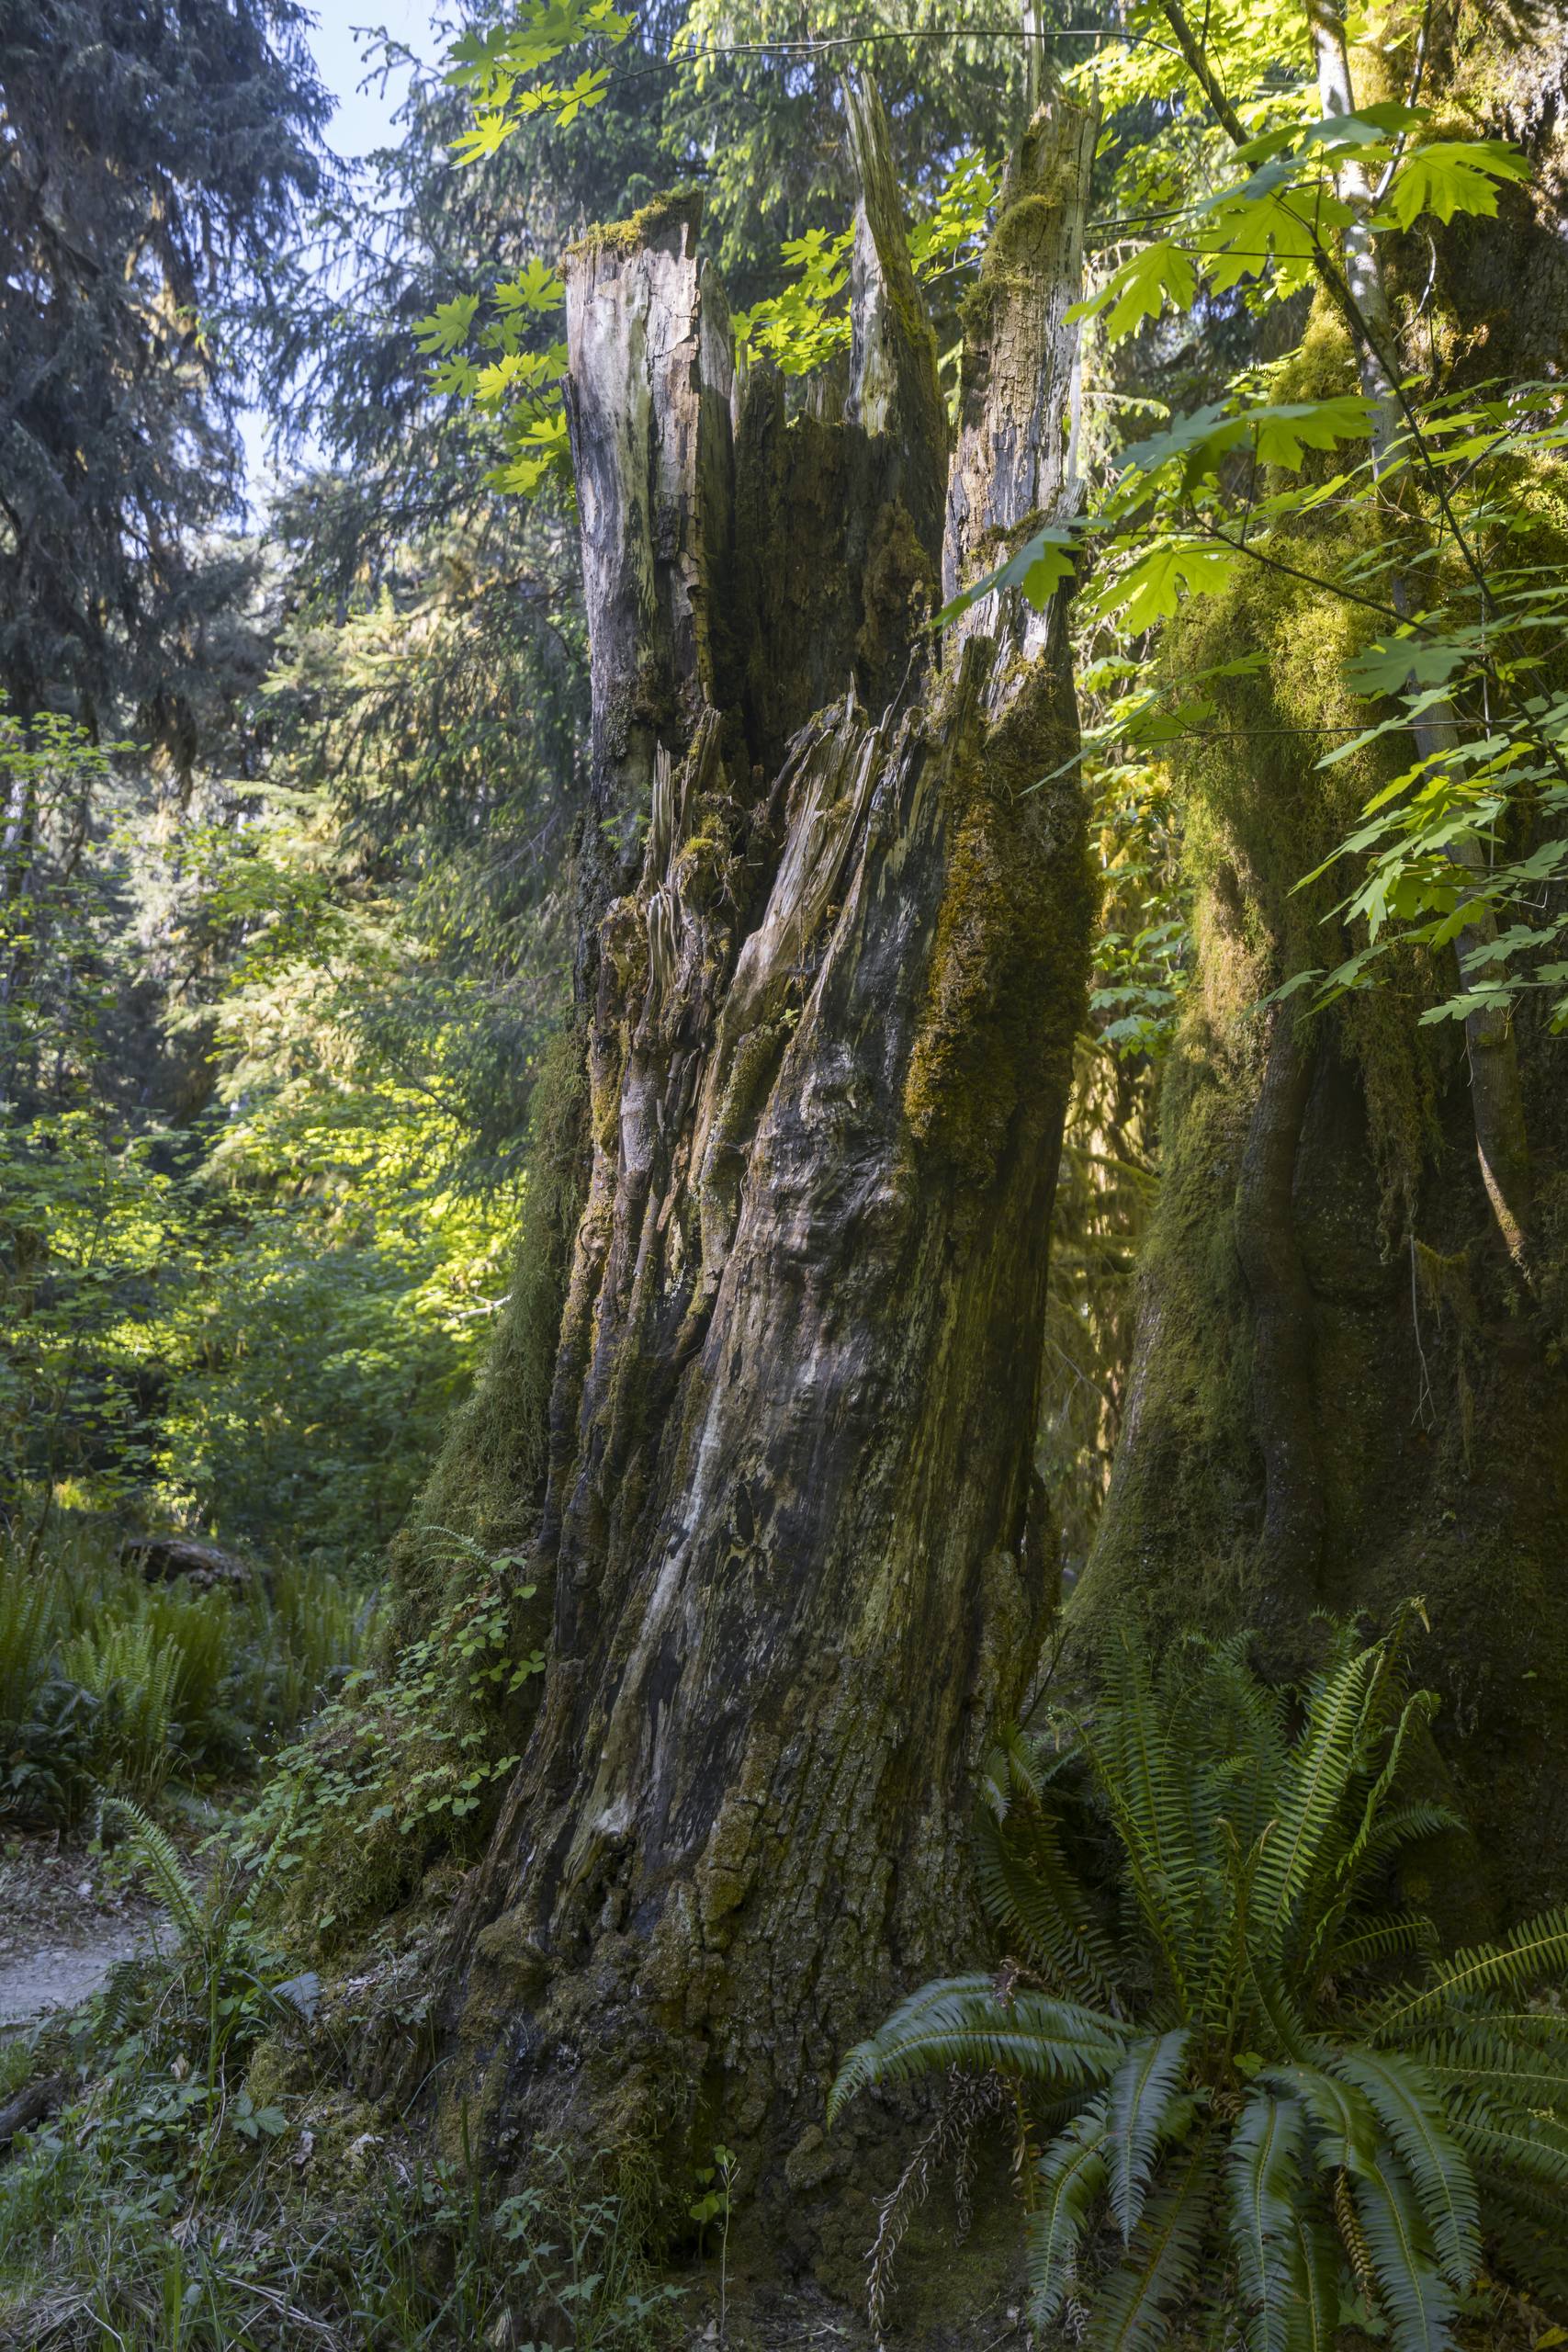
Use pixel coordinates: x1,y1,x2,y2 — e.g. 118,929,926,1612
0,0,329,729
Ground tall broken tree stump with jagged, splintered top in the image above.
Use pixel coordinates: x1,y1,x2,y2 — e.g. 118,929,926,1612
434,87,1093,2246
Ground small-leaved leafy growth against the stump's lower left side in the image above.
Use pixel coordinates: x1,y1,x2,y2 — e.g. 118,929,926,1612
237,1526,546,1950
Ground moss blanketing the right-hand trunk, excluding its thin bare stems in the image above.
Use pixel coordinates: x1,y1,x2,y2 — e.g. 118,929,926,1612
1072,299,1568,1919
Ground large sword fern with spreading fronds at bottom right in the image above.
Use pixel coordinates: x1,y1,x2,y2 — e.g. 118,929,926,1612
829,1604,1568,2352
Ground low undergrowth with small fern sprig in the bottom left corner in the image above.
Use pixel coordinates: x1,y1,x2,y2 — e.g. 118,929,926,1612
0,1809,677,2352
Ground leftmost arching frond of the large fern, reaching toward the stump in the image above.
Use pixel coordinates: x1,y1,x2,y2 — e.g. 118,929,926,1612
828,1975,1126,2124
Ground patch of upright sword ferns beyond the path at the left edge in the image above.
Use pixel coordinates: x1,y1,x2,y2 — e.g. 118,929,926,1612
0,1521,374,1827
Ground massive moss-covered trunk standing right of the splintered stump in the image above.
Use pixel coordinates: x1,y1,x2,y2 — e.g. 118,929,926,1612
1075,9,1568,1927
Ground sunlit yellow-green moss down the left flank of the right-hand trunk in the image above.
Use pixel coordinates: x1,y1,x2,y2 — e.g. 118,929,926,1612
1075,493,1434,1625
